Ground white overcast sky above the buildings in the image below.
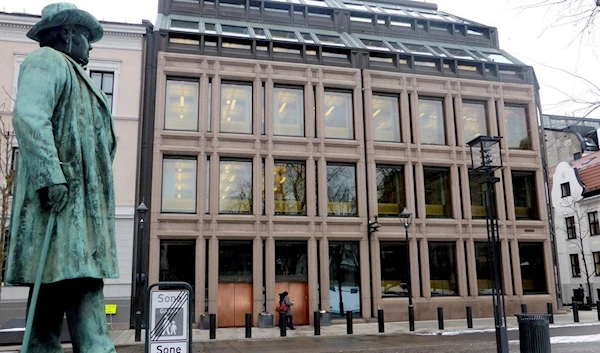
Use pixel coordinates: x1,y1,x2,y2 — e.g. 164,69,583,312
0,0,600,119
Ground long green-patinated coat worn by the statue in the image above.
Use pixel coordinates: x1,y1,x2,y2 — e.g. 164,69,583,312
5,47,119,284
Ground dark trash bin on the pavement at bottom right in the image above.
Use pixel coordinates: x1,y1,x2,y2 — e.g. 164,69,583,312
516,314,550,353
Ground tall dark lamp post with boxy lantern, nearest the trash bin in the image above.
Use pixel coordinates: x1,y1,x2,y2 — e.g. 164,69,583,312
467,136,508,353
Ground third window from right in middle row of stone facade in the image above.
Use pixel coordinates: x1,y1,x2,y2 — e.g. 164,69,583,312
423,167,452,218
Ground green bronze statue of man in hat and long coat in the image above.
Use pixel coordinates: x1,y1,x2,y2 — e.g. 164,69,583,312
5,3,119,353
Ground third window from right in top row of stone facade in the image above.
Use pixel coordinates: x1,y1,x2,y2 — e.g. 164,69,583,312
419,98,446,145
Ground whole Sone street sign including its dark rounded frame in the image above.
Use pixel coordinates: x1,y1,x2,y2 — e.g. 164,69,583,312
145,282,194,353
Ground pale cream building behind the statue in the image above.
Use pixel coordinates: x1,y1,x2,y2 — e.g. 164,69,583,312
0,12,146,324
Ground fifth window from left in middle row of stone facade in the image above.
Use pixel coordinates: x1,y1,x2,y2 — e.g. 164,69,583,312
375,166,406,217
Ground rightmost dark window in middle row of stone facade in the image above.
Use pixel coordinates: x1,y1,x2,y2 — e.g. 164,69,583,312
512,172,539,219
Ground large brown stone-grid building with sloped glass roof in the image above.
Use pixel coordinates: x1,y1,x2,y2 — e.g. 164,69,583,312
134,0,555,327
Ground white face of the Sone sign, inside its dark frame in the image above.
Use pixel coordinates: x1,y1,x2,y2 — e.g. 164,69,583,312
149,290,190,340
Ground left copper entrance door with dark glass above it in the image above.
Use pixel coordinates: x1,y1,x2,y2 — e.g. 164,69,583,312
217,241,254,327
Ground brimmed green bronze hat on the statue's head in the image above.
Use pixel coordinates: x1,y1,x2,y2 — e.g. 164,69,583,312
27,2,104,43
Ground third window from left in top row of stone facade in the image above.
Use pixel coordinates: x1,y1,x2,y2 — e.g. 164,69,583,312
273,87,304,137
